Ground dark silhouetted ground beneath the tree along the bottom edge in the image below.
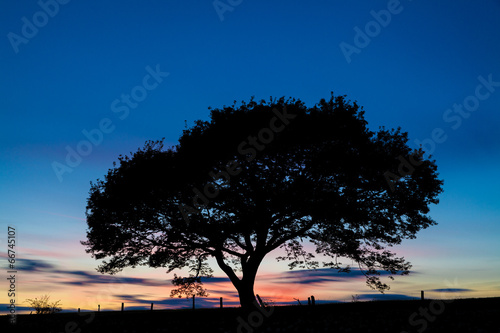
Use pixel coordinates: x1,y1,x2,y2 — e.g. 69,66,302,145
0,298,500,333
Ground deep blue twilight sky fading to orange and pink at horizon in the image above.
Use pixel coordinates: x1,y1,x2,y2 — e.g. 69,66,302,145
0,0,500,314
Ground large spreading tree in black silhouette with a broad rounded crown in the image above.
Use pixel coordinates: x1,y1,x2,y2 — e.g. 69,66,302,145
82,95,442,308
